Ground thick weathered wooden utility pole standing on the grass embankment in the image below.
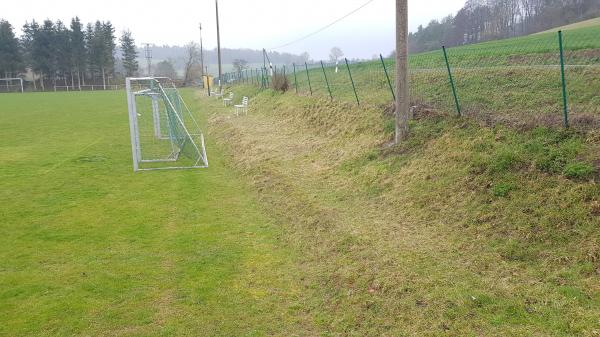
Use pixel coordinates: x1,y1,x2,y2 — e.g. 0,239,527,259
394,0,410,144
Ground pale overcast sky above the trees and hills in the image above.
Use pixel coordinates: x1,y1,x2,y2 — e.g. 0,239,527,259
0,0,465,59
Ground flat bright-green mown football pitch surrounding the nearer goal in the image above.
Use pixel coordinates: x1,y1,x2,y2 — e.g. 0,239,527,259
0,92,311,336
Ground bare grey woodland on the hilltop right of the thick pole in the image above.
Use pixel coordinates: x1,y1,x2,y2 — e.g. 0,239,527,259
409,0,600,53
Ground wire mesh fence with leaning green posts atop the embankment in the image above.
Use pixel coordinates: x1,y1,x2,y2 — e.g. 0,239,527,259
226,24,600,126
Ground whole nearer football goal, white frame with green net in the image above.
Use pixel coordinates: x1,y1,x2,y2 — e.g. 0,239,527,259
126,77,208,171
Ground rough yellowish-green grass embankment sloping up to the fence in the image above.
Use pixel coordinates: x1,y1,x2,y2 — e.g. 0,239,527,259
207,86,600,336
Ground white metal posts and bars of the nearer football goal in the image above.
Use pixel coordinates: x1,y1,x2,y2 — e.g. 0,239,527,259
125,77,208,172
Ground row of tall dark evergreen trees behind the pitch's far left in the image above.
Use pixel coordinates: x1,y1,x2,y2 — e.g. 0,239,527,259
0,17,138,90
